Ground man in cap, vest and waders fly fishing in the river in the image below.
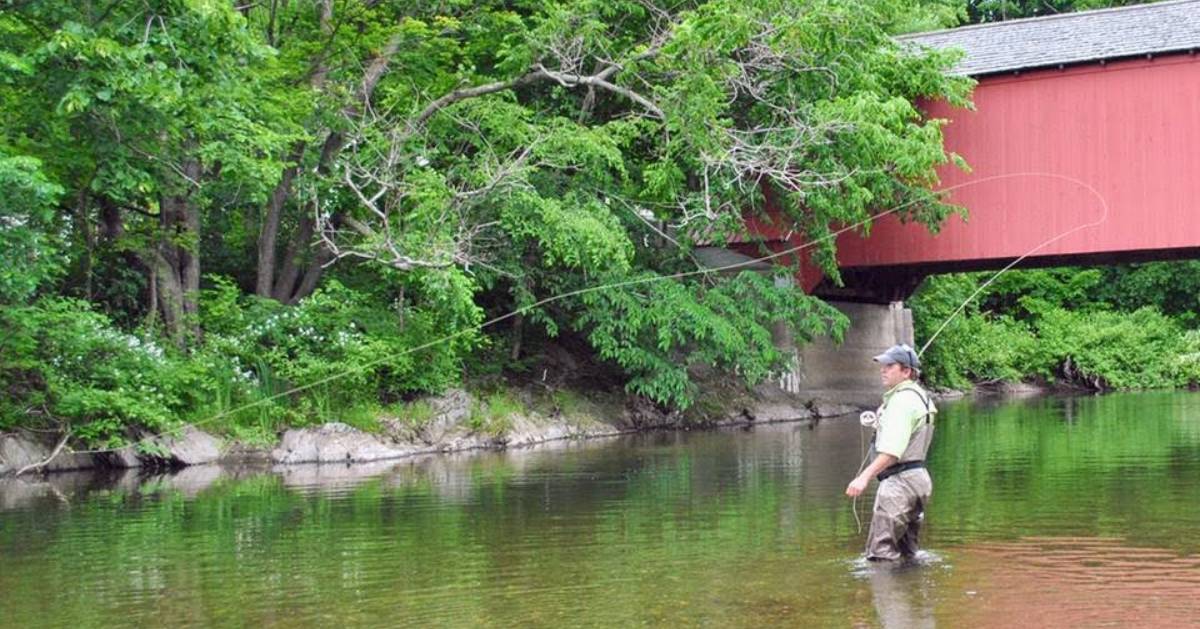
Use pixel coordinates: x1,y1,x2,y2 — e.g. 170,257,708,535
846,345,937,561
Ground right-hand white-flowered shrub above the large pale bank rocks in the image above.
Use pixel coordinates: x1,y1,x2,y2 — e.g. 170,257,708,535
202,280,478,420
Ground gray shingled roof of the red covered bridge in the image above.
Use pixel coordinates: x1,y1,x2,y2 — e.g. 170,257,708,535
899,0,1200,76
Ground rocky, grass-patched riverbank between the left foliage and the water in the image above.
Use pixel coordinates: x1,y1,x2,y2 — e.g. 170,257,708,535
0,384,859,475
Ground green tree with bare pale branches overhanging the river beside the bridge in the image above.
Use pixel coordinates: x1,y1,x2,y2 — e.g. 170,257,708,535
320,1,970,406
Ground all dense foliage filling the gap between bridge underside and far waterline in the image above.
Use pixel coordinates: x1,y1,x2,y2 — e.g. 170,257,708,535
911,262,1200,390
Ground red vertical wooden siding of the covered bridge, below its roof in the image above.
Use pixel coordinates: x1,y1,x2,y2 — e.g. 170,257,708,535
748,53,1200,301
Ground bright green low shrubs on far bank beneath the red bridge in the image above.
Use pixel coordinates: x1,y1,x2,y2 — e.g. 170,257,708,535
911,271,1200,389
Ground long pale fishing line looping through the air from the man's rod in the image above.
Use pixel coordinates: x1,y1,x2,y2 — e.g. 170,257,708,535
56,173,1108,454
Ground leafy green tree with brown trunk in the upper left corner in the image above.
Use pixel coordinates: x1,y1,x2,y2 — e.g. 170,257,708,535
0,0,296,343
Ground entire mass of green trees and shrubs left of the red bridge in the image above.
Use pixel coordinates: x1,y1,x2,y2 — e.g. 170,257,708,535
0,0,970,443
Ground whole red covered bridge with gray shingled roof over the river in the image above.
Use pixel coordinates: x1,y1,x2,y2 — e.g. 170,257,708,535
739,0,1200,304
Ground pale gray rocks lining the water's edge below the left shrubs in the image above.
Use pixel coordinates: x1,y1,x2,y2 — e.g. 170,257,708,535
0,389,859,475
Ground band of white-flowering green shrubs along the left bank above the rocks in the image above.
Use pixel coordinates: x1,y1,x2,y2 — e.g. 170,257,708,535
0,274,480,445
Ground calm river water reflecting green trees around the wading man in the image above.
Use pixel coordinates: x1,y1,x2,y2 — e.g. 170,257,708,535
0,393,1200,628
